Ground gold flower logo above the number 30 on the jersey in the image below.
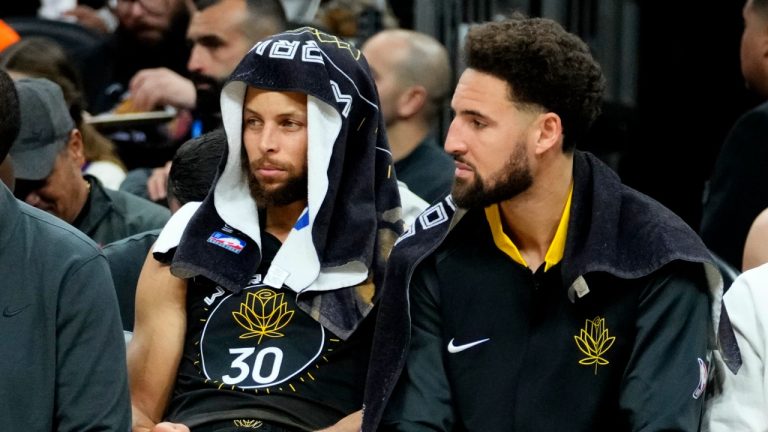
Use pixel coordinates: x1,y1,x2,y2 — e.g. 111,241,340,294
232,289,293,344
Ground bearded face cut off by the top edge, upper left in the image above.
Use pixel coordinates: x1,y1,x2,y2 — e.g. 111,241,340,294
116,0,185,43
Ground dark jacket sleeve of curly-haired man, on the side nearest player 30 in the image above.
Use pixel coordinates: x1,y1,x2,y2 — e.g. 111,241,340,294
380,266,454,431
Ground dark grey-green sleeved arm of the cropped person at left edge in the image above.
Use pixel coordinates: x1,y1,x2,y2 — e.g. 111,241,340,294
57,255,130,432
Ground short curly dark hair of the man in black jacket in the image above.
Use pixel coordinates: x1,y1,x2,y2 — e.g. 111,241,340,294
464,13,605,152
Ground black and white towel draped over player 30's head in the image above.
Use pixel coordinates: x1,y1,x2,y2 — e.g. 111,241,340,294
160,27,402,338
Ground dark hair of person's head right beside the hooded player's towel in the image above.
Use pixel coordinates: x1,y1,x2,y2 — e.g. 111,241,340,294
168,128,227,205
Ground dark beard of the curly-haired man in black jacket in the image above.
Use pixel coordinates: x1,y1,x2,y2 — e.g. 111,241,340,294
451,143,533,209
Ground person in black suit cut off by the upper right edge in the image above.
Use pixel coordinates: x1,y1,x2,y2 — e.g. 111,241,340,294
700,0,768,269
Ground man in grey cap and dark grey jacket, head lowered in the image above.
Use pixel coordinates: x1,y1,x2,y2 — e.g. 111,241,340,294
10,78,170,245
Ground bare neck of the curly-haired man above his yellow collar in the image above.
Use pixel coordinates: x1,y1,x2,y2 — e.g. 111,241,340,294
499,158,573,270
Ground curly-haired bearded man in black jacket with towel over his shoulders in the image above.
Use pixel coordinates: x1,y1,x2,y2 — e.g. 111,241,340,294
363,15,737,432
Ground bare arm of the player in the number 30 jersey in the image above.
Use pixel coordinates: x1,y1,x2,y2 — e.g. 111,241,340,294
128,252,187,431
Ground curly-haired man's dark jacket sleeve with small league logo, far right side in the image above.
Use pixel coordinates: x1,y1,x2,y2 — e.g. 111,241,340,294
619,262,714,432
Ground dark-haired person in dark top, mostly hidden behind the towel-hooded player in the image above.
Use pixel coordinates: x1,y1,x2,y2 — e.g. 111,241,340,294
104,129,227,331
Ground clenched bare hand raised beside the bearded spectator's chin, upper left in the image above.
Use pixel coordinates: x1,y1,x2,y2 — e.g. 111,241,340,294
129,68,197,111
